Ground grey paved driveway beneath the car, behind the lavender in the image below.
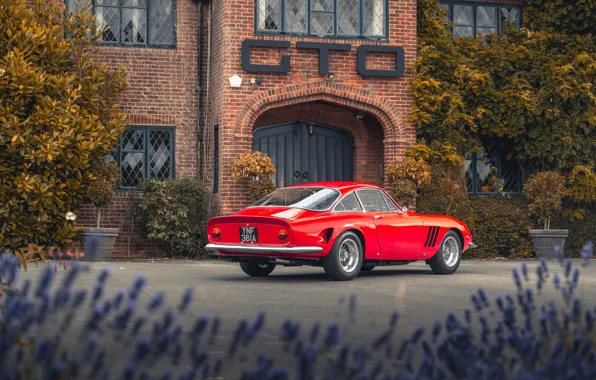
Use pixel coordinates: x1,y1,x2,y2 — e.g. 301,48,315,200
11,261,596,378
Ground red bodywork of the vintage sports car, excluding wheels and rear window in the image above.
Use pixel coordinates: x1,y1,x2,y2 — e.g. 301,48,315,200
206,182,474,280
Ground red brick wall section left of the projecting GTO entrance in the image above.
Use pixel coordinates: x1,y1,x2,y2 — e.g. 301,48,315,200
79,0,199,257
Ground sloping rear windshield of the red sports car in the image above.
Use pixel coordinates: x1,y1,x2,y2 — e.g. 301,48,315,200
253,187,340,211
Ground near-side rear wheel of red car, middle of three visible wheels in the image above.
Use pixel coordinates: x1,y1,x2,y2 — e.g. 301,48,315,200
323,231,364,281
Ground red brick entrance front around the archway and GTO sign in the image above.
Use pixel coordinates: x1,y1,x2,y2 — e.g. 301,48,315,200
203,0,416,213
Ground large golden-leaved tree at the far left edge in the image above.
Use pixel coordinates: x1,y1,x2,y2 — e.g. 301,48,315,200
0,0,125,248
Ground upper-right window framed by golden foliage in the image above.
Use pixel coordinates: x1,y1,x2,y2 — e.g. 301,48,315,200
440,1,521,38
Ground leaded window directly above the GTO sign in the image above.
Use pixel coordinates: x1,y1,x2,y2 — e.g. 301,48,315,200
256,0,388,38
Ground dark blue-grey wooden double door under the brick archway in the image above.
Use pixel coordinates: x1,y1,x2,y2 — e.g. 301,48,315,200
253,122,354,187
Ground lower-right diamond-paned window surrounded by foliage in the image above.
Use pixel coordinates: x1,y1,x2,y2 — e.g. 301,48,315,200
464,146,522,194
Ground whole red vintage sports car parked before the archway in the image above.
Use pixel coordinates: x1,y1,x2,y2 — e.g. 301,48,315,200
206,182,475,280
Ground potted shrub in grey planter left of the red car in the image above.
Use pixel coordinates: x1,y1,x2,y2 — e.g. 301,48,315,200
81,162,120,261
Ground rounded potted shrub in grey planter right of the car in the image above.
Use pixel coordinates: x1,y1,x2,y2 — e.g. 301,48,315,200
524,171,569,259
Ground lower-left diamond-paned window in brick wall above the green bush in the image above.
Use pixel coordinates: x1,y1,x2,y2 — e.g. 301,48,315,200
113,127,174,189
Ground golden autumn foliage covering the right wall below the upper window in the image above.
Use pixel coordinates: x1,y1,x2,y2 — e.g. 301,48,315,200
413,0,596,174
